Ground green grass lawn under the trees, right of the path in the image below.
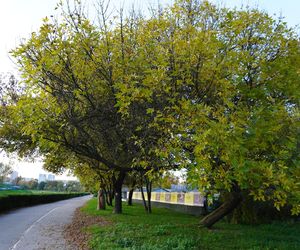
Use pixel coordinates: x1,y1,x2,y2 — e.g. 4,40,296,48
82,199,300,250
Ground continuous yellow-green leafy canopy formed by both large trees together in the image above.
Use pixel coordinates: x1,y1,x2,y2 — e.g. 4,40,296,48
0,0,300,226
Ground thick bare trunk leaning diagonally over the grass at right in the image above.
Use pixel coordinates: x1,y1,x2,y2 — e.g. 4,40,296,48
200,191,242,228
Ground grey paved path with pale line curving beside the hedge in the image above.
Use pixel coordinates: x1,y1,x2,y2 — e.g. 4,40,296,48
0,196,91,250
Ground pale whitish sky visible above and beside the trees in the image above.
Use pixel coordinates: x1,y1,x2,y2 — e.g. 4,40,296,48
0,0,300,178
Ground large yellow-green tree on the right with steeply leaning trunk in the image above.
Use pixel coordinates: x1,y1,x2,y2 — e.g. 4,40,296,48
118,0,300,227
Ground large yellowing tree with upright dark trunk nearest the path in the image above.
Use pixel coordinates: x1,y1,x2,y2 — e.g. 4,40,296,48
0,1,171,213
